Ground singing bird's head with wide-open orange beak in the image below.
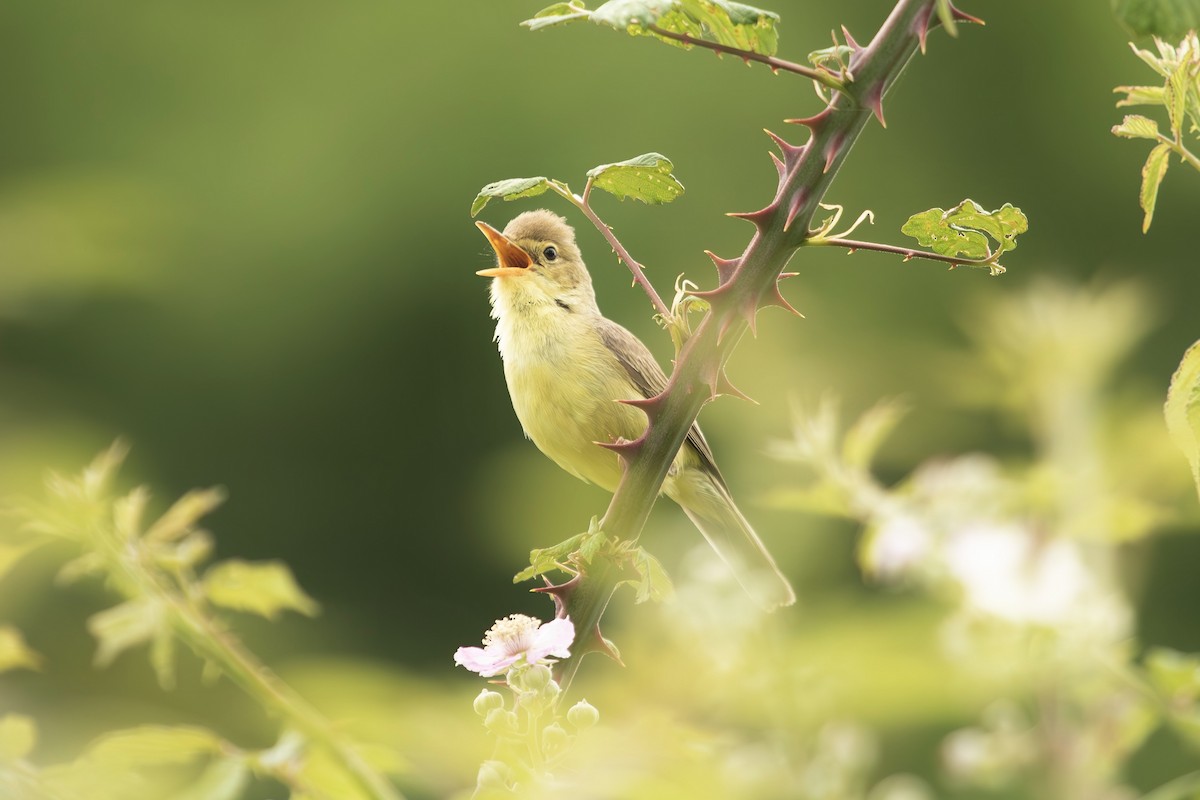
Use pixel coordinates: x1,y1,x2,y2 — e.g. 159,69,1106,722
475,209,595,311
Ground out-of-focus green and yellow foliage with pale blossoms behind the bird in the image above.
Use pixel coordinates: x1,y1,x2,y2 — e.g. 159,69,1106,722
0,0,1200,800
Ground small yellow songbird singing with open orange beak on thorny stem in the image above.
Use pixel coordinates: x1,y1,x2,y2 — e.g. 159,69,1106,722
475,209,796,609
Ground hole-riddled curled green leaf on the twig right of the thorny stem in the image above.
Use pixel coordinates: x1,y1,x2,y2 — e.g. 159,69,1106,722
900,200,1030,260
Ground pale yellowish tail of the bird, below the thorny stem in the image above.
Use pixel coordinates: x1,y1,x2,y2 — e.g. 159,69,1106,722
667,470,796,610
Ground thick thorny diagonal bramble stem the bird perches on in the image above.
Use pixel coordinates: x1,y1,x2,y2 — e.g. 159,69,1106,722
562,0,935,688
